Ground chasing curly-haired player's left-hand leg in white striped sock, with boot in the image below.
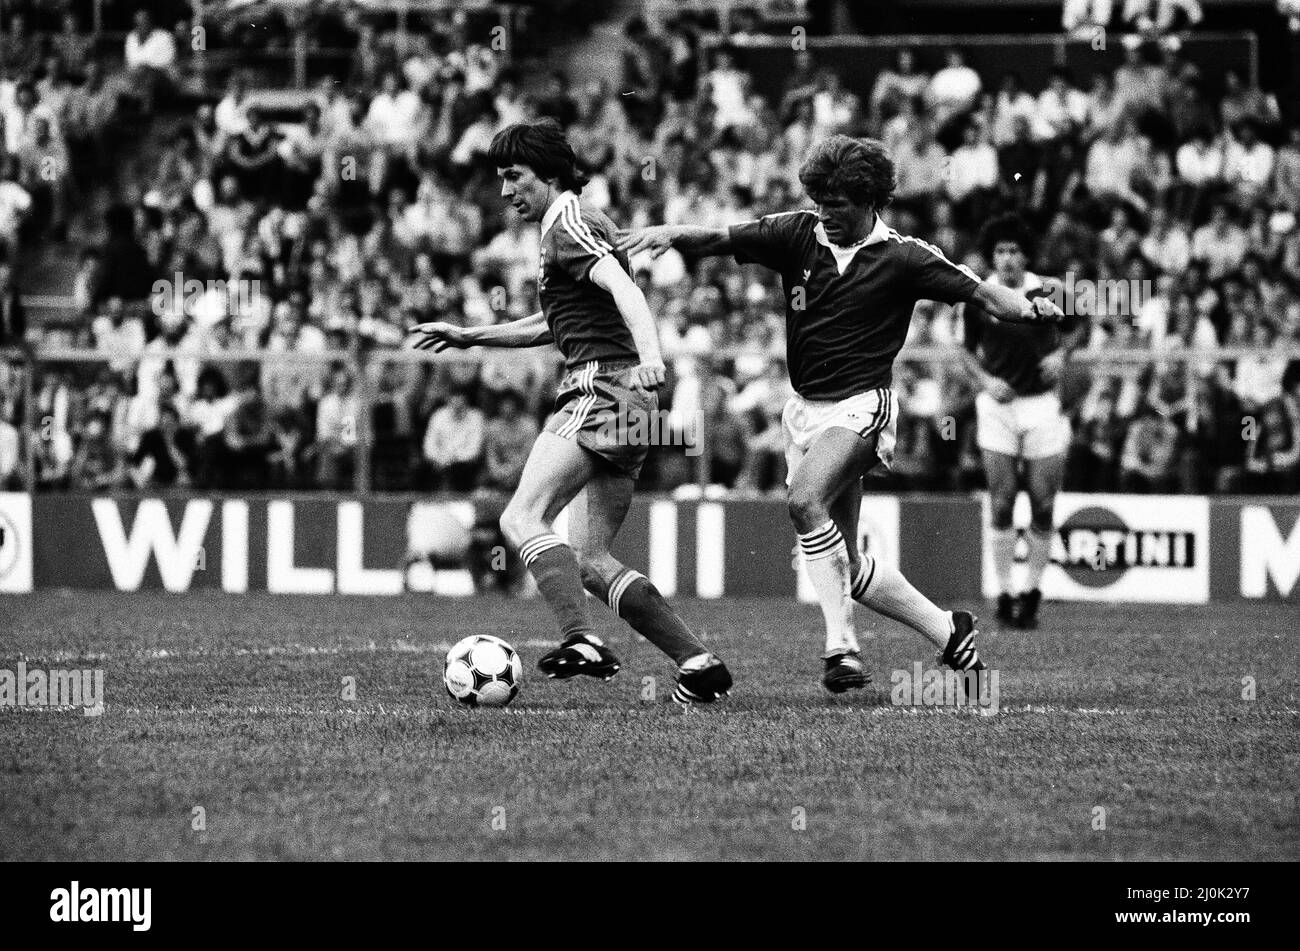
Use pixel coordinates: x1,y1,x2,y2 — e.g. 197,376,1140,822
788,427,875,692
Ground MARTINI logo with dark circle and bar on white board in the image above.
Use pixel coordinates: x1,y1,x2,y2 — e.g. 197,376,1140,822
1052,505,1196,587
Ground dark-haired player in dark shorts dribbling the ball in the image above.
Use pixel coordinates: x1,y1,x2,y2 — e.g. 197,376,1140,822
411,120,732,704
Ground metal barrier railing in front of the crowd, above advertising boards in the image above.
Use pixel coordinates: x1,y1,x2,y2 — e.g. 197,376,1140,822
0,344,1300,495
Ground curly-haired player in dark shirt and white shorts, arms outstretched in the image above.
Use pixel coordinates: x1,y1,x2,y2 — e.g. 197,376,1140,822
619,135,1061,692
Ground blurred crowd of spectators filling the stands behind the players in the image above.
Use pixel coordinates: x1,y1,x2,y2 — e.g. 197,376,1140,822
0,0,1300,494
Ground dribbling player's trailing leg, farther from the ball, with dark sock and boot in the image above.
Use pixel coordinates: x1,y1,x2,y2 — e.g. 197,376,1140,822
569,472,732,703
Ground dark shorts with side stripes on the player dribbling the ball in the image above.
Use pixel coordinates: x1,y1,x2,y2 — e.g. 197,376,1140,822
546,360,659,479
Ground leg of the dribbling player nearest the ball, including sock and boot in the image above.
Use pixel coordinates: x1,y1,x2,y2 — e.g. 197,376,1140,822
501,431,619,679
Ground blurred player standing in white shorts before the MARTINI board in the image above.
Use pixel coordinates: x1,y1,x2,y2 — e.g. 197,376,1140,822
961,214,1088,628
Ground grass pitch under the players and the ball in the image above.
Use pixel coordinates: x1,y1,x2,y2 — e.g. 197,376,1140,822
0,592,1300,860
